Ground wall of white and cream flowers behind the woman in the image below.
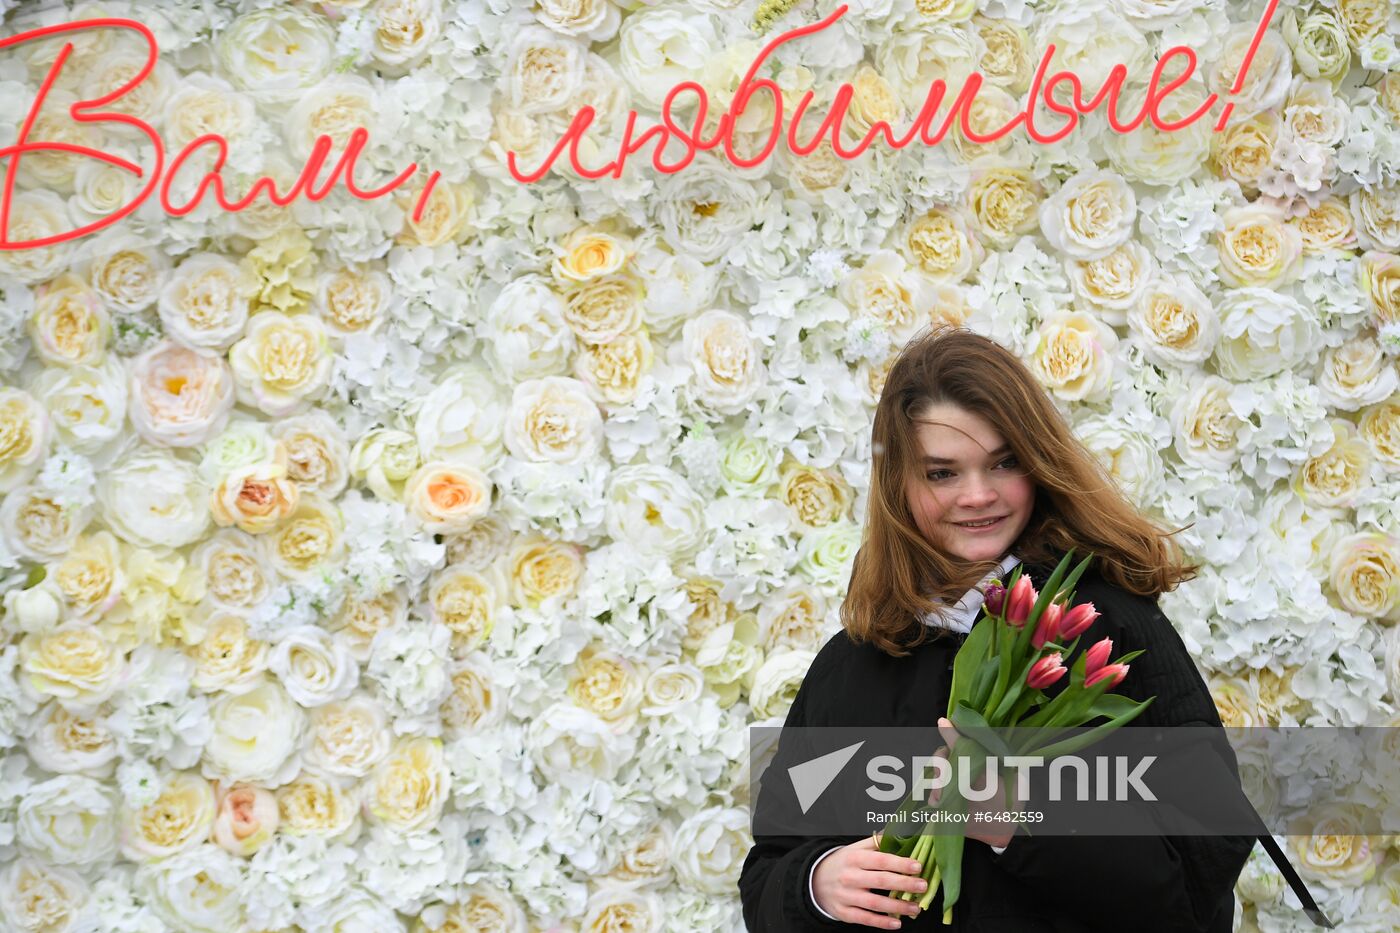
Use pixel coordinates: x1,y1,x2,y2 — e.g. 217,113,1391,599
0,0,1400,933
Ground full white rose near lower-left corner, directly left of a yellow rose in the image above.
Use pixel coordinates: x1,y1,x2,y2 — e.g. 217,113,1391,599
14,775,118,866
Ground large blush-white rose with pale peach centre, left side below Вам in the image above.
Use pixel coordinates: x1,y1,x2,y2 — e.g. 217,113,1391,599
127,340,235,447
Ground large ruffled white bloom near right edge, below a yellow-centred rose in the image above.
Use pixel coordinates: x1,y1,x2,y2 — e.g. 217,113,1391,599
1215,287,1322,382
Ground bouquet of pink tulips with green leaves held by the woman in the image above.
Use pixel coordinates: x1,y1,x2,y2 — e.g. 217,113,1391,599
878,549,1155,923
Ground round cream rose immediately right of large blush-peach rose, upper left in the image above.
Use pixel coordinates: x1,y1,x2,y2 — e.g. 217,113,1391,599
228,311,332,417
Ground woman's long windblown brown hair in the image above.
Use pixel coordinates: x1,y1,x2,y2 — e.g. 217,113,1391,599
841,325,1200,657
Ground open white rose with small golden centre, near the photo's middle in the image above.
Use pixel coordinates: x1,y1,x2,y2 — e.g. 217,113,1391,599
606,464,706,558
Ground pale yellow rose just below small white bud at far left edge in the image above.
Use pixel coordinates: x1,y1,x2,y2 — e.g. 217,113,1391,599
20,623,126,712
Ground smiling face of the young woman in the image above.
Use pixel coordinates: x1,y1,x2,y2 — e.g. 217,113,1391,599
907,403,1036,562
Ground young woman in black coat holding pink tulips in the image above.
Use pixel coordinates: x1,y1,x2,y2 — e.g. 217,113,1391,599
739,328,1310,933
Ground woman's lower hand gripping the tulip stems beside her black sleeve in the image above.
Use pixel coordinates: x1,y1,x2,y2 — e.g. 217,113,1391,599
812,836,928,930
